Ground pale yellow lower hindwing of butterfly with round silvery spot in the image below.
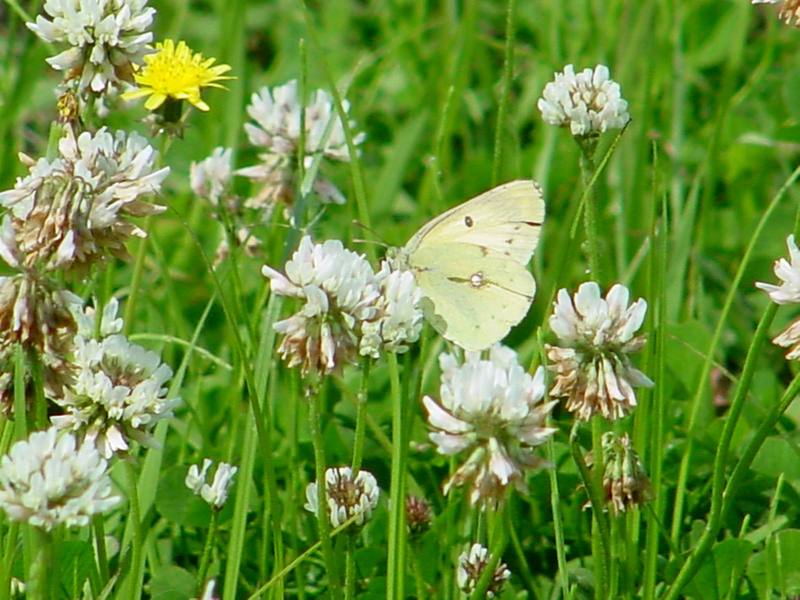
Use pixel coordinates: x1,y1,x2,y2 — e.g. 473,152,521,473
409,242,536,351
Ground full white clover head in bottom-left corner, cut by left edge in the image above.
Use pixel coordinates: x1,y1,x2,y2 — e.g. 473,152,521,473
0,427,120,531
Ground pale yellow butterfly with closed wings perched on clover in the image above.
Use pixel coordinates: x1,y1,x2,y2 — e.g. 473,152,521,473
396,180,545,351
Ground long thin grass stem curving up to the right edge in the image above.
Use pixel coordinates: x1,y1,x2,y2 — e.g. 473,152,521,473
671,166,800,548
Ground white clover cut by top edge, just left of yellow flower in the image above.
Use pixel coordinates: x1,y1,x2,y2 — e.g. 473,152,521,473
27,0,156,94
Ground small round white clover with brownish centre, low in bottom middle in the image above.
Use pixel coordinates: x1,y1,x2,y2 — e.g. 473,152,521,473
304,467,381,527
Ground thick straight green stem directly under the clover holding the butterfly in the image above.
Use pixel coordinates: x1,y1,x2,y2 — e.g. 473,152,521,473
386,352,406,599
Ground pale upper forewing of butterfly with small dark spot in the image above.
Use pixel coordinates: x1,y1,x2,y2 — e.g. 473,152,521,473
406,179,545,265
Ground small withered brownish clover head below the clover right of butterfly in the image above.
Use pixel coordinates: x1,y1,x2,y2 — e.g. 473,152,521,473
586,431,650,514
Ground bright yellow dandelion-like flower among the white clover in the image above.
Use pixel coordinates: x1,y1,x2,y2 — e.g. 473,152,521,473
122,39,233,111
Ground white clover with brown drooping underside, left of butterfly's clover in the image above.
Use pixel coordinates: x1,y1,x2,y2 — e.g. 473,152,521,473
261,236,381,374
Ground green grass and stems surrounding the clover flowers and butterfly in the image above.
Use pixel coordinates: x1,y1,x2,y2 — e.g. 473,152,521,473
0,0,800,600
